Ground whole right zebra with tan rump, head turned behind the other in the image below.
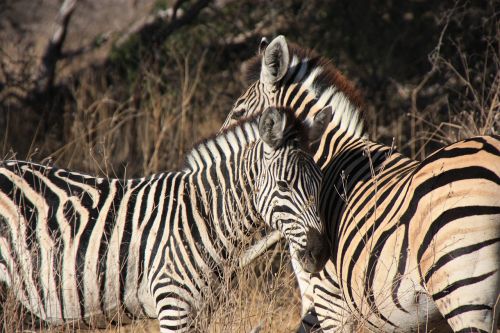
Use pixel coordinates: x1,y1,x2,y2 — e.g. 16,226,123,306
224,36,500,332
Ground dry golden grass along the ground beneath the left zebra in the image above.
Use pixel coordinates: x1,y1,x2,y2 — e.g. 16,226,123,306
0,243,300,333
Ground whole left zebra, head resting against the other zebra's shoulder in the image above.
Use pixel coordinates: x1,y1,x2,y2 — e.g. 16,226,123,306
0,108,331,332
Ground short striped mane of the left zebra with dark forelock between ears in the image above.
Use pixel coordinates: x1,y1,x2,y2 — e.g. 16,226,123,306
184,107,309,171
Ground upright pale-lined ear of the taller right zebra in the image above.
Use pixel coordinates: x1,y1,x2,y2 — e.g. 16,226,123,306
260,36,290,84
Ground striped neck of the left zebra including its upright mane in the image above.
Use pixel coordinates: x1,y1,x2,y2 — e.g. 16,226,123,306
183,121,264,259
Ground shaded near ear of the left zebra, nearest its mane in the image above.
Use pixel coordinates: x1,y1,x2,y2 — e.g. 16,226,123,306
259,107,286,149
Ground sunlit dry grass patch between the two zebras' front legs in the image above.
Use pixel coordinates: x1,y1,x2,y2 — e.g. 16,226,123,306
201,243,300,333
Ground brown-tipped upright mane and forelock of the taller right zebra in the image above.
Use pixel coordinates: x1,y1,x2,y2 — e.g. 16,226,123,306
243,43,365,137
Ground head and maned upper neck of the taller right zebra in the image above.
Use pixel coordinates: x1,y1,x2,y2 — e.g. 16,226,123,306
223,36,363,140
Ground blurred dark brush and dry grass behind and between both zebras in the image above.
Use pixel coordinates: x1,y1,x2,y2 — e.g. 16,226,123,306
0,0,500,332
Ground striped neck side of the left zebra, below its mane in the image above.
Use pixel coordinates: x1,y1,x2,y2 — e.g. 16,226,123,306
186,134,263,260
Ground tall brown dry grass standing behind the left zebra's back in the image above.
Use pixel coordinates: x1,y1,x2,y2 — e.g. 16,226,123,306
39,45,227,177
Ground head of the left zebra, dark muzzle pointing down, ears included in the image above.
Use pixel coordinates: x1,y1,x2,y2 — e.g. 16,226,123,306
254,107,331,273
